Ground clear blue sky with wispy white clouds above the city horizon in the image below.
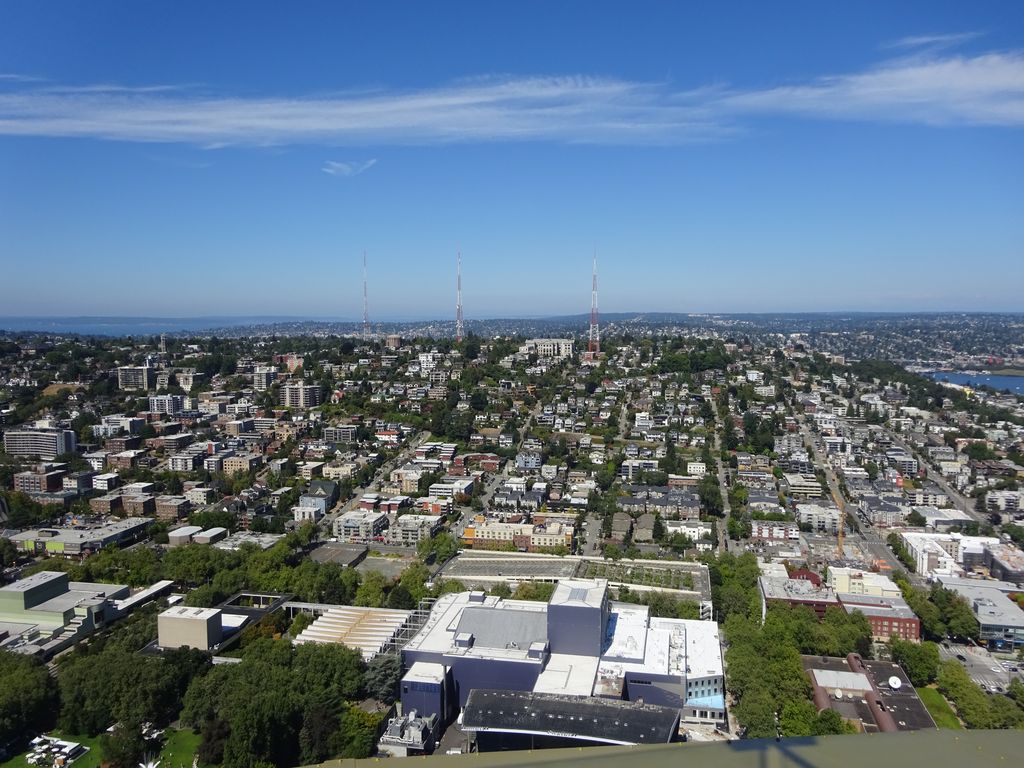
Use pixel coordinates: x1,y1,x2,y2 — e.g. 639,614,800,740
0,0,1024,319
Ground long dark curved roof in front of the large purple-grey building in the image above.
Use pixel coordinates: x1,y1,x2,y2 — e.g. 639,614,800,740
463,688,679,744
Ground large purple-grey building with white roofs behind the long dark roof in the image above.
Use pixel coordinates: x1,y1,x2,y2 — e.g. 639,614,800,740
401,580,726,741
